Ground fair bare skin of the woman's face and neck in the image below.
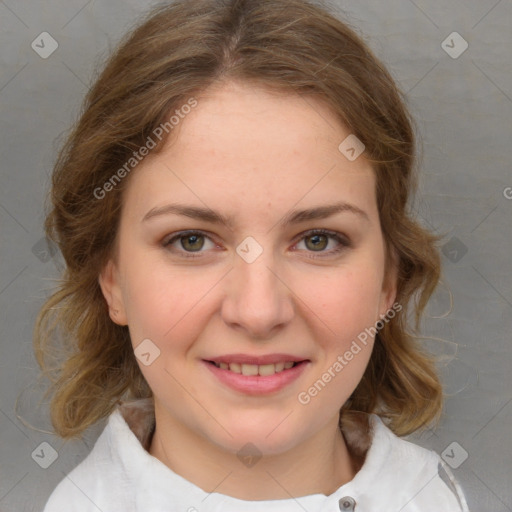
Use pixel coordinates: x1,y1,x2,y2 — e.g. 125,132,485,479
99,82,396,500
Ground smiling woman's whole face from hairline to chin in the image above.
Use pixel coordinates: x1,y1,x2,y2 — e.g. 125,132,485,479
100,79,395,454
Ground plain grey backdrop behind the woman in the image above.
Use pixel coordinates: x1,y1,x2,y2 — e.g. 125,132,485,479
0,0,512,512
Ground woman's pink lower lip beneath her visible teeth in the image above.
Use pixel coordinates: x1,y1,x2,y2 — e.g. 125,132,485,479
203,361,309,395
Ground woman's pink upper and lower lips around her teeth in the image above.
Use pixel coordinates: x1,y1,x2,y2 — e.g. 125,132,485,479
202,354,311,395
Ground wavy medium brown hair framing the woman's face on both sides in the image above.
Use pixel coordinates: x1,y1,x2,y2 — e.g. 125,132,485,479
34,0,442,438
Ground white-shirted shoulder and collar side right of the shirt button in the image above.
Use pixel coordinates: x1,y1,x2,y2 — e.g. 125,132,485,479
346,414,468,512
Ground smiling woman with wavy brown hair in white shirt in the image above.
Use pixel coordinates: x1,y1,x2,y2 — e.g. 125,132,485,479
36,0,467,512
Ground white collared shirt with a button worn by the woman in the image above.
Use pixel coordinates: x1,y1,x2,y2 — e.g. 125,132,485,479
44,401,468,512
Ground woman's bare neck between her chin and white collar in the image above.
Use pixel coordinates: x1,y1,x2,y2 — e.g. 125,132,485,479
149,408,362,500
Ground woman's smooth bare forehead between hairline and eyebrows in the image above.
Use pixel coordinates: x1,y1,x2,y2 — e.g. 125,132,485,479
120,82,376,222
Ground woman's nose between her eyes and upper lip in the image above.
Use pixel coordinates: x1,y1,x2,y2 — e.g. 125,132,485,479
221,244,295,341
